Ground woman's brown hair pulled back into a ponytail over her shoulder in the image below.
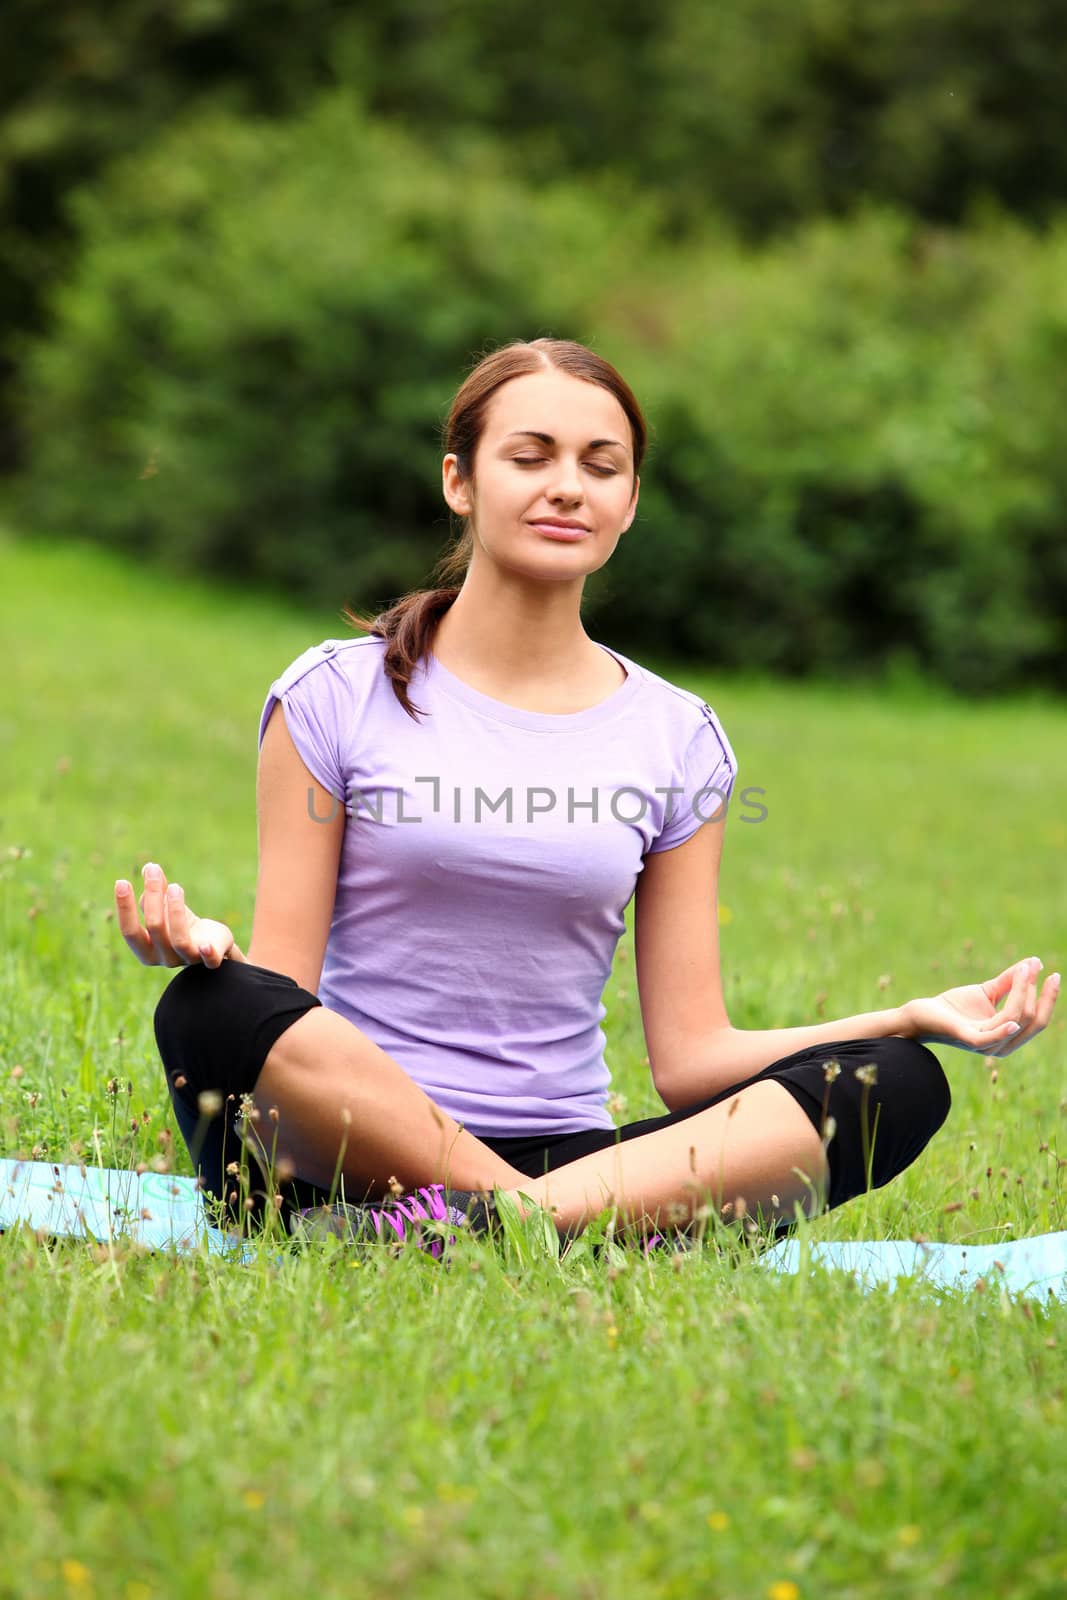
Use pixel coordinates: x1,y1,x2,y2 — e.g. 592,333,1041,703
342,339,648,720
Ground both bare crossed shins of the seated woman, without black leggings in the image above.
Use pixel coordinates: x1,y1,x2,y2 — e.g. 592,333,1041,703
253,1006,827,1232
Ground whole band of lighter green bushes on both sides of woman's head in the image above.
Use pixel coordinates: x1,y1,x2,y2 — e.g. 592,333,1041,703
21,96,1067,693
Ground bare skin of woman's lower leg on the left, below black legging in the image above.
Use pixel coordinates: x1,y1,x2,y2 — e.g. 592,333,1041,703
241,1006,526,1198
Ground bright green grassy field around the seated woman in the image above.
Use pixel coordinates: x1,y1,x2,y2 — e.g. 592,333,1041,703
0,541,1067,1600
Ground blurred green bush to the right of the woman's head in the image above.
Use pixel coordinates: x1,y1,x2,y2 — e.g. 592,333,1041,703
601,213,1067,693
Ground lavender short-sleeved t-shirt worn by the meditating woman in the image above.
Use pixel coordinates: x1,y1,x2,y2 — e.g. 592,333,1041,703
259,635,737,1136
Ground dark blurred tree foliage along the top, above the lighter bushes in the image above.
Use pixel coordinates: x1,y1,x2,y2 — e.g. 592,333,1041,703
0,0,1067,470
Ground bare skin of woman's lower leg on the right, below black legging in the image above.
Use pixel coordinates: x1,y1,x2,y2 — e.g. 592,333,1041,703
510,1080,829,1232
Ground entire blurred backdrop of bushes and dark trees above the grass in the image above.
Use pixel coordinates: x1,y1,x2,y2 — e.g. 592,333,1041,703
0,0,1067,696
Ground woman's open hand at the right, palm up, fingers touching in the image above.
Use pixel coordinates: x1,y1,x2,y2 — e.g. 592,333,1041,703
901,955,1059,1056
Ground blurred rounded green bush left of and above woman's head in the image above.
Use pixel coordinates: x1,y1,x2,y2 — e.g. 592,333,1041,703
19,96,668,605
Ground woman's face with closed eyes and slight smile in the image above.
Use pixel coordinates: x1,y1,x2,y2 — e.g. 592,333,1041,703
443,368,640,579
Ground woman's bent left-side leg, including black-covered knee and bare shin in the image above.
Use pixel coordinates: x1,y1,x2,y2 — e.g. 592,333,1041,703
155,962,522,1206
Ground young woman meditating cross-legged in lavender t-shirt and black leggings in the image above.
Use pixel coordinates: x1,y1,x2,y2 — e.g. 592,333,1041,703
115,339,1059,1234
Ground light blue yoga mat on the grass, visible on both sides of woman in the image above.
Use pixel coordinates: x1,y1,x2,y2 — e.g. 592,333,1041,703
0,1160,1067,1301
